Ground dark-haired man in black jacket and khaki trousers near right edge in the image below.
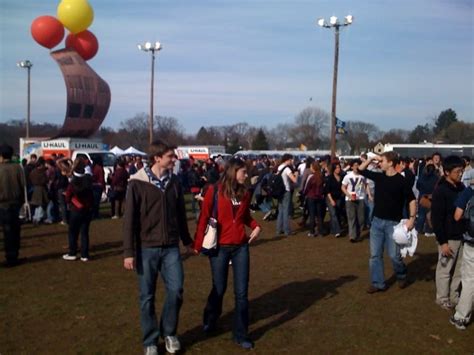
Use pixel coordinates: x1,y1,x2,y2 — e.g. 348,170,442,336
431,155,464,309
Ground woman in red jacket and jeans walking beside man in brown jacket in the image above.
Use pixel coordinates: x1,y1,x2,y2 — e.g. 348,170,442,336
194,158,261,349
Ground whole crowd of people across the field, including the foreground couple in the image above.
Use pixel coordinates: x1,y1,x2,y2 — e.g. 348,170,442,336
0,141,474,354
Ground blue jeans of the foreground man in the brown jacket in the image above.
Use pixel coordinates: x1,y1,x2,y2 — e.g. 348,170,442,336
137,246,184,346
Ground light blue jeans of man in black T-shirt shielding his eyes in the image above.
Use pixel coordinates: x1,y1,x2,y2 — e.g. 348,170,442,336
369,217,407,288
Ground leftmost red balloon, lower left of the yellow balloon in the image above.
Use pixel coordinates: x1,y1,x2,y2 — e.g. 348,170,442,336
31,16,64,49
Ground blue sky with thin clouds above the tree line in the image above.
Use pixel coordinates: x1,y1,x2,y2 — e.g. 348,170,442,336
0,0,474,133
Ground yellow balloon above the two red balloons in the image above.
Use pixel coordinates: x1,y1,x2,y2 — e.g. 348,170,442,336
57,0,94,34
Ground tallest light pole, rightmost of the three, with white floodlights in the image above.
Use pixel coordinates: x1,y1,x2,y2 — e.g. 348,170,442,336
318,15,354,159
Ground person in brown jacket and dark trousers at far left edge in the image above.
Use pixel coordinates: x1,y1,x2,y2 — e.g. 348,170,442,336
0,144,25,266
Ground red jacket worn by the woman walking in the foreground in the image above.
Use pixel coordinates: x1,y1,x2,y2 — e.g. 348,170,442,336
194,185,259,251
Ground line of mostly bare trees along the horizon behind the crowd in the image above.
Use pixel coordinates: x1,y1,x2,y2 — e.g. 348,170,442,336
0,106,474,154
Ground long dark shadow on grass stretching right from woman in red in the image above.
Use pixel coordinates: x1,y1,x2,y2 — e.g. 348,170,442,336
181,275,357,347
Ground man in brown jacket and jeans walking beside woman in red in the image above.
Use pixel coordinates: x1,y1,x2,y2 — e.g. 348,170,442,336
123,141,193,355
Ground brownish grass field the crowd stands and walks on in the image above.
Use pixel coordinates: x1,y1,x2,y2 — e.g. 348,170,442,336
0,200,474,355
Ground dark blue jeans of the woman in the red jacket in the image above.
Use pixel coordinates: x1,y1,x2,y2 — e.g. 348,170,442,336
203,244,250,342
